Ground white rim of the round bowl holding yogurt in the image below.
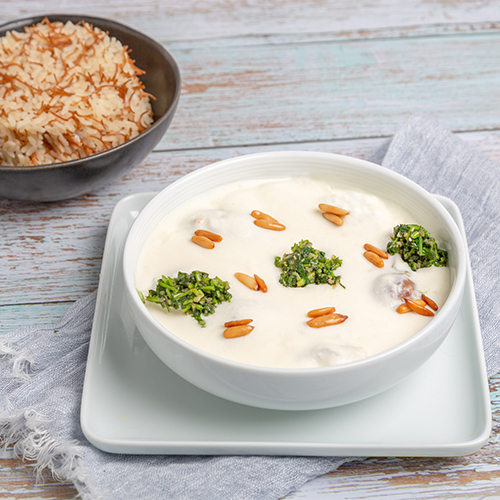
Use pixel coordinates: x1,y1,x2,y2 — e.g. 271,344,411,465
121,150,468,378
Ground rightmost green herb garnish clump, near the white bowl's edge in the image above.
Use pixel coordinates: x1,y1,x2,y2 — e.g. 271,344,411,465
387,224,448,271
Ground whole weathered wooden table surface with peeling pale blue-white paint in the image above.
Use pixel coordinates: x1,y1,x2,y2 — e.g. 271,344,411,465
0,0,500,499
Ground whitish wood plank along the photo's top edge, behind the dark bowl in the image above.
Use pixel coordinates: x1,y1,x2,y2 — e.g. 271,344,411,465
0,0,500,45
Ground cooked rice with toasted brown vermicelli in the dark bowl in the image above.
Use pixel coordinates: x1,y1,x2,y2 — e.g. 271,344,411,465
0,19,153,166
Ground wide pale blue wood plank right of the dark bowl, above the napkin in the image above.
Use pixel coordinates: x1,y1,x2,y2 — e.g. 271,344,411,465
158,34,500,149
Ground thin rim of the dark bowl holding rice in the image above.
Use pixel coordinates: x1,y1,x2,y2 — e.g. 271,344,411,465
0,13,182,172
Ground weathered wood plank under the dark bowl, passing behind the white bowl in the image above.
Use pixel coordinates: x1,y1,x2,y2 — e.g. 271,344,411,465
0,132,500,308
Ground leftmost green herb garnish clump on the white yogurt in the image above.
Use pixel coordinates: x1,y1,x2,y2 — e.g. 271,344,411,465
143,271,231,326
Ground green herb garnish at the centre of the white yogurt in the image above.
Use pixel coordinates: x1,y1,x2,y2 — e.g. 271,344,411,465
274,240,342,287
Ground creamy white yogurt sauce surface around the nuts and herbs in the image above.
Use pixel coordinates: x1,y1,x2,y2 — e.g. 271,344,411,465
135,178,450,368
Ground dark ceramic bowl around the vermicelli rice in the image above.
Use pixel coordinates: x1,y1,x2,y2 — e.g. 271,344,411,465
0,14,181,201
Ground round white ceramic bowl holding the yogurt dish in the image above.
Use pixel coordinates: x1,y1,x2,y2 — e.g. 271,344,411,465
123,151,467,410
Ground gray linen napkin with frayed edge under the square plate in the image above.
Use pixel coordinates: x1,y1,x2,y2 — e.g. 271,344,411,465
0,111,500,500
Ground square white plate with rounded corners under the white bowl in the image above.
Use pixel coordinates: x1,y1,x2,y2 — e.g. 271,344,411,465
81,193,491,456
